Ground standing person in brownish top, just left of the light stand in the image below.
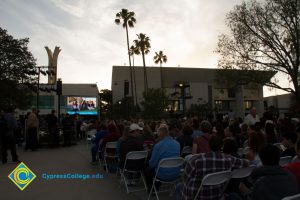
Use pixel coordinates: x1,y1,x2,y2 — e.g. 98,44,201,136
25,108,39,151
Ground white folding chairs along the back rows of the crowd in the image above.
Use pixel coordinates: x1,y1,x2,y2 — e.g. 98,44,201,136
98,142,298,200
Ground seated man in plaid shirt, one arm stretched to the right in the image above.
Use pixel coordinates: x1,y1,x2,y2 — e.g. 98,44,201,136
177,136,249,200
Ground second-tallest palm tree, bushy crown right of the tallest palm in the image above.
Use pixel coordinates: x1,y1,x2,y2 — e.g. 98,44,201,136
133,33,151,92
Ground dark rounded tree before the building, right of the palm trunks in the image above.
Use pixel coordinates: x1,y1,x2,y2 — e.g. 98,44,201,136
141,88,169,119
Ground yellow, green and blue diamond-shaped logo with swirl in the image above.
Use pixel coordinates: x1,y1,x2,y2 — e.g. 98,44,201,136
8,162,36,190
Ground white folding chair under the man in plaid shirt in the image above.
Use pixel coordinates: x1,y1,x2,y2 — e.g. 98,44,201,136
194,171,232,200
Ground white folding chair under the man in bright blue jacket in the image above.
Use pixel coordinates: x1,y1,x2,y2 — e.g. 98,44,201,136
148,157,184,200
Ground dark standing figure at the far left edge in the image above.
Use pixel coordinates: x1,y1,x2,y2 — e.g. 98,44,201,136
0,107,20,164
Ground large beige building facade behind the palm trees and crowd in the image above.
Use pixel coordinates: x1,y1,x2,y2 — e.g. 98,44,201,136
111,66,273,117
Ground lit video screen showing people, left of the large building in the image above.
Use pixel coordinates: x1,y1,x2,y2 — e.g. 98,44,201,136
67,97,98,115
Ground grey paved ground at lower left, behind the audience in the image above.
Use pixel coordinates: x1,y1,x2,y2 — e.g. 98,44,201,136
0,143,175,200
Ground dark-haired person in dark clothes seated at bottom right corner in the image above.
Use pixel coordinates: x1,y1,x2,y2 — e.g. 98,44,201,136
240,144,299,200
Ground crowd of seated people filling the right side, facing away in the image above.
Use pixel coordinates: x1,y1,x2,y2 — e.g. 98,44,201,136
85,109,300,199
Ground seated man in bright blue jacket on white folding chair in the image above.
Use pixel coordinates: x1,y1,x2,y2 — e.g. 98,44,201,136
145,125,180,190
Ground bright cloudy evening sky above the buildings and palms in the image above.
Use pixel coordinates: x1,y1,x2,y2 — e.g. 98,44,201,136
0,0,288,96
